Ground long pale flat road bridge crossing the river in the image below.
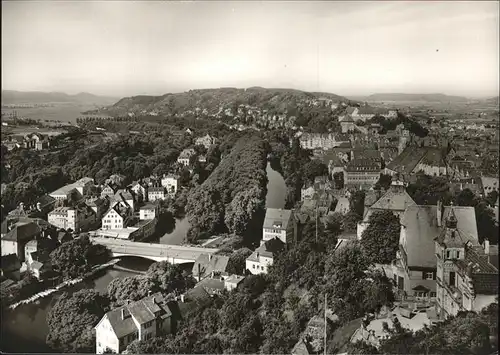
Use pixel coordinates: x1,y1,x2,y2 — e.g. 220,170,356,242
90,237,219,264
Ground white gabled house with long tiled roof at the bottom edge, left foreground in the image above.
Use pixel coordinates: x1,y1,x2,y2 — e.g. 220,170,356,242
95,293,172,354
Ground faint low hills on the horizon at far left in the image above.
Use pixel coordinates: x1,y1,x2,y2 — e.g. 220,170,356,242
2,90,117,105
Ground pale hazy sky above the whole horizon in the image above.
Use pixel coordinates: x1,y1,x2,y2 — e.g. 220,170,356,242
2,0,499,96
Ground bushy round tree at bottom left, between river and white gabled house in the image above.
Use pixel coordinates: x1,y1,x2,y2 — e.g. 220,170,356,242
47,289,109,352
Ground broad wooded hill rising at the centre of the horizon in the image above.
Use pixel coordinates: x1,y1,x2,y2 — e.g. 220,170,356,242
106,87,349,115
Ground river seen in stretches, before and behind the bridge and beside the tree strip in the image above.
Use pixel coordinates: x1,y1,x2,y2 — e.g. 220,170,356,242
0,163,286,353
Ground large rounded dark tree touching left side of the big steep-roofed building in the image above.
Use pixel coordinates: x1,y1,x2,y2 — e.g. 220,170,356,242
361,211,401,264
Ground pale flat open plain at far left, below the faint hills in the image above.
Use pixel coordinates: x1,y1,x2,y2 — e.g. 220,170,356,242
2,104,104,123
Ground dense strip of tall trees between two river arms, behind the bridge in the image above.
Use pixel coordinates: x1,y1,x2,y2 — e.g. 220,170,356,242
186,135,267,241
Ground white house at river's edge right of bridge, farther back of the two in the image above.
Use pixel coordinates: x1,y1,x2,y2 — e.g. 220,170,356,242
261,208,297,244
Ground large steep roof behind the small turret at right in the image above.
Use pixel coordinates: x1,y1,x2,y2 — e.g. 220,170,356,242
400,205,478,267
